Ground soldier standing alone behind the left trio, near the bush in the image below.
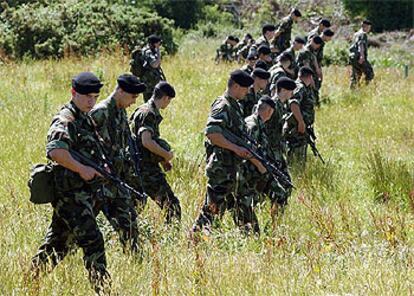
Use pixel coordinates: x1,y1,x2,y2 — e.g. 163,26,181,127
140,35,167,102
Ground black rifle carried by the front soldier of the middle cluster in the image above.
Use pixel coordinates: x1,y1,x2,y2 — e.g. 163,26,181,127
223,130,294,188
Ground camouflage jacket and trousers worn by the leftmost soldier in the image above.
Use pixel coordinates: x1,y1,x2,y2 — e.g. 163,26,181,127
32,102,109,289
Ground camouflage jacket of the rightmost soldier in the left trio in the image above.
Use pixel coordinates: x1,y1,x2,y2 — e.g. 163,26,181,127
130,99,170,167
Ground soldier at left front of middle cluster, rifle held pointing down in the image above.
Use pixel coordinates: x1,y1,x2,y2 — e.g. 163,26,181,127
192,70,266,232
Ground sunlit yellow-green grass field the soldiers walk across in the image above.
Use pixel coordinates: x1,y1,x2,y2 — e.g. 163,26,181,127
0,41,414,295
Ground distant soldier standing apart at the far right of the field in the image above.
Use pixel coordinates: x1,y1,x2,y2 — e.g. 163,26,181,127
349,20,374,89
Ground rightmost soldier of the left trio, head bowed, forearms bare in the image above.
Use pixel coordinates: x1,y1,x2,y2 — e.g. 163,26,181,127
130,81,181,224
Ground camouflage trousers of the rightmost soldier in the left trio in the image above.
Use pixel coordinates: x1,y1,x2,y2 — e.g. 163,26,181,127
134,163,181,224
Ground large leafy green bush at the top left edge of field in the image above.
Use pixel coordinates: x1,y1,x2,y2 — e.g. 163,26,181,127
0,0,177,58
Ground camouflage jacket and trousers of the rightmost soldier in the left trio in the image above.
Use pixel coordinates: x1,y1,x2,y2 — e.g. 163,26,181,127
130,98,181,223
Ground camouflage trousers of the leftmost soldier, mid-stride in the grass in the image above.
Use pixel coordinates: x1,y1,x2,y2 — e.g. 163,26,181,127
32,186,110,291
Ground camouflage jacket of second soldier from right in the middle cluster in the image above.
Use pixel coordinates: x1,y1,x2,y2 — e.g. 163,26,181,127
265,96,286,153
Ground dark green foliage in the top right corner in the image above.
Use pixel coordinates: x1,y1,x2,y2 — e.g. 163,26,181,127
342,0,414,32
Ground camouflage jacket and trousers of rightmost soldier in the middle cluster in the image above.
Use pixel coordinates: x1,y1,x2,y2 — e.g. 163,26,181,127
284,80,315,165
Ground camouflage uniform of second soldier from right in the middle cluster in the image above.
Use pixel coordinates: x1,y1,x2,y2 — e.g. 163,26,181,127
265,96,291,206
